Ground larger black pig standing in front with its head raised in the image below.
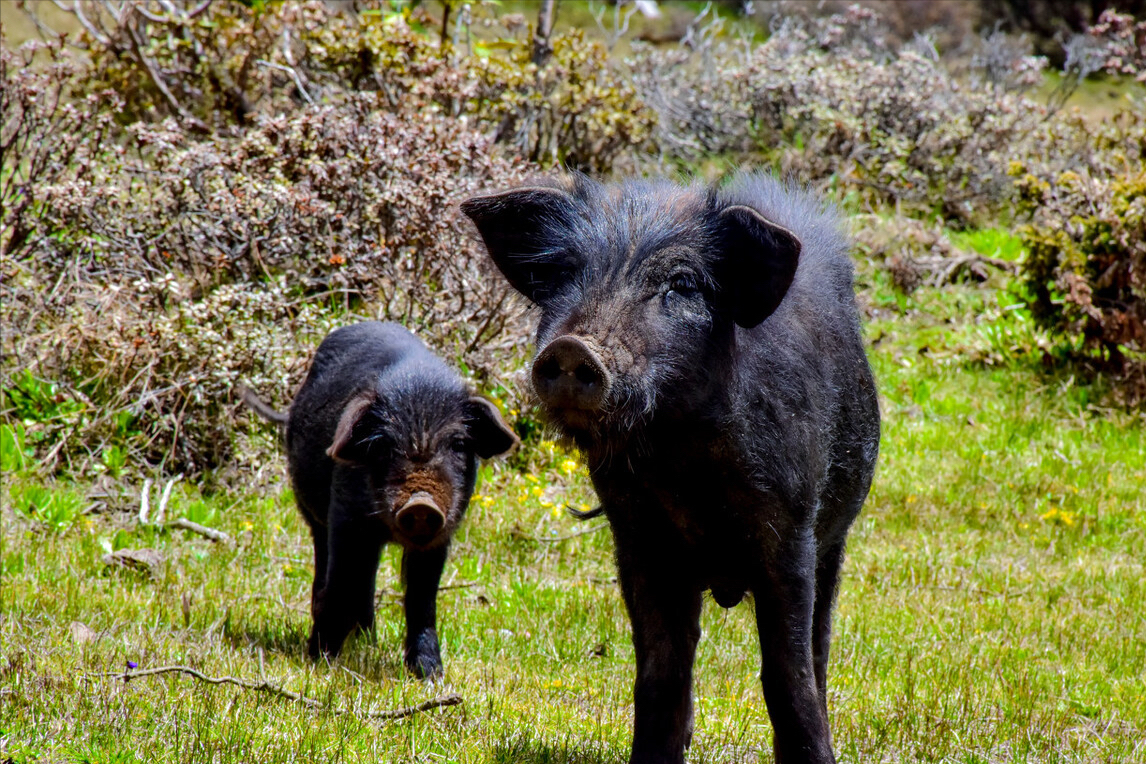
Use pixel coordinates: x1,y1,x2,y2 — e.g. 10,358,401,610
462,174,879,764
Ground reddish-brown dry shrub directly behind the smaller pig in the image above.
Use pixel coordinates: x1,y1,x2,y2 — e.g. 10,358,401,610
3,83,525,473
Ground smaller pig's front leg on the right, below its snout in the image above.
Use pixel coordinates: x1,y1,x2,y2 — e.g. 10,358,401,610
402,544,449,679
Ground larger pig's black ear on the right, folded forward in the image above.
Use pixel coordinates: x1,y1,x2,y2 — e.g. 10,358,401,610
717,204,801,329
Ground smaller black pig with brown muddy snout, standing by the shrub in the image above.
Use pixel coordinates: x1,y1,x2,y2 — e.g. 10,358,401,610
253,322,517,677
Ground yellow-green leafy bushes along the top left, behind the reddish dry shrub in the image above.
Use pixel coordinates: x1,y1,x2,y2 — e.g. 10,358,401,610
40,0,656,173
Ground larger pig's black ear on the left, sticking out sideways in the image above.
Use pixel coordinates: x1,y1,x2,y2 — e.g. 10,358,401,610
461,186,574,302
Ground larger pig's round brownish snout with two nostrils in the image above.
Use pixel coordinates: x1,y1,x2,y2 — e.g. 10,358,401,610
533,334,612,411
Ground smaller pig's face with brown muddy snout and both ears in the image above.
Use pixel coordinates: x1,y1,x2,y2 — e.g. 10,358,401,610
328,391,517,549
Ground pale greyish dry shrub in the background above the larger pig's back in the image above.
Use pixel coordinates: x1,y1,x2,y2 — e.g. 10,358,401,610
633,6,1141,225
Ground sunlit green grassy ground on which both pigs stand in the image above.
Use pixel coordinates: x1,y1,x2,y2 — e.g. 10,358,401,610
0,236,1146,764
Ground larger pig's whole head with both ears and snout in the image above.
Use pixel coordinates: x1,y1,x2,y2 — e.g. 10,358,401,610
462,178,800,447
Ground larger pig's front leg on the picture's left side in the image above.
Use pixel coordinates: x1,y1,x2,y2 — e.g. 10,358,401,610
617,533,701,764
